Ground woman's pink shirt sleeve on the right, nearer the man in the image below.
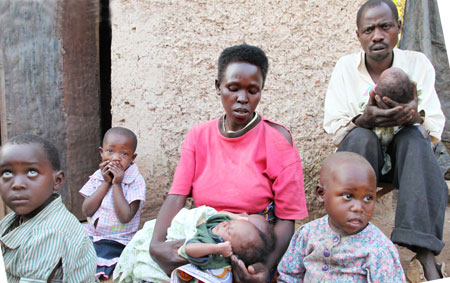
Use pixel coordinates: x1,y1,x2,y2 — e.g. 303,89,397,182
272,161,308,220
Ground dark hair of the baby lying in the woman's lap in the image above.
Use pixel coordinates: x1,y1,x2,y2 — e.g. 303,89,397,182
233,225,276,266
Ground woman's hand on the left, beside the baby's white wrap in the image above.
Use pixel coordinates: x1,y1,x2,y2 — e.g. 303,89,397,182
150,240,188,277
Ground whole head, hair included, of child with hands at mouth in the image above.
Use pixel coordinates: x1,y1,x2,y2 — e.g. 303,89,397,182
99,127,137,170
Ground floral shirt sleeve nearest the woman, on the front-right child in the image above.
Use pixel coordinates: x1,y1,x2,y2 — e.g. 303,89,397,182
277,227,306,282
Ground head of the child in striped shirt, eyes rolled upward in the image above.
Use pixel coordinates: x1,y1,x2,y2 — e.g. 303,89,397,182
0,135,64,220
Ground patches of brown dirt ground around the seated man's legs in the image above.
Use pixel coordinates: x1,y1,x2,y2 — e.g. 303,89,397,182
372,192,450,280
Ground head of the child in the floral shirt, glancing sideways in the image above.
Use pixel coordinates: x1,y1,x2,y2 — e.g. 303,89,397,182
316,152,376,235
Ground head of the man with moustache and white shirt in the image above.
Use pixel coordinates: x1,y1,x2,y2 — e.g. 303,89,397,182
356,3,401,62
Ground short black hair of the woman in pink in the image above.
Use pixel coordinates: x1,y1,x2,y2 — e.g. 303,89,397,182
217,44,269,87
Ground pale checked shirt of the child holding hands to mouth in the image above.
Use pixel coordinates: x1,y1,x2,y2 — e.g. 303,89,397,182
80,163,145,245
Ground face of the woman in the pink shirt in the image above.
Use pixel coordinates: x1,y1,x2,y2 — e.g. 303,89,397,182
216,62,263,131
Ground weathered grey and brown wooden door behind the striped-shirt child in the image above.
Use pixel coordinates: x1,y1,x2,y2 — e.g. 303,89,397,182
0,0,101,219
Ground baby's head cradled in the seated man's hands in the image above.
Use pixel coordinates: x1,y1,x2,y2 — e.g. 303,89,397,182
375,67,414,104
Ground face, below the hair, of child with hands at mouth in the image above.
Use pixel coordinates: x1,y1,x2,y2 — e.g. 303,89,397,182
99,133,136,170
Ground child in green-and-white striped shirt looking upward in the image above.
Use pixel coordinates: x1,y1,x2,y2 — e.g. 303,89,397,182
0,135,96,283
